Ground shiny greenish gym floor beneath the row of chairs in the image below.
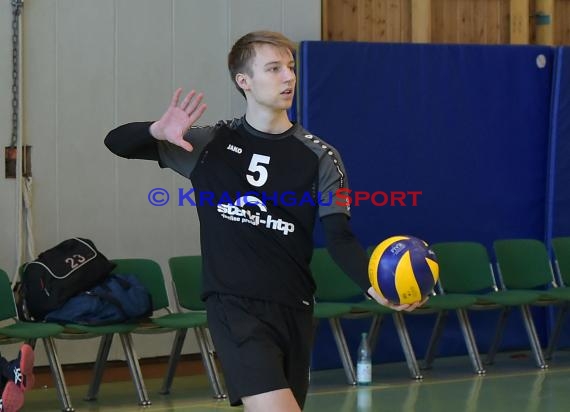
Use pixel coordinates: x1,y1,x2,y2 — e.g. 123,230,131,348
22,351,570,412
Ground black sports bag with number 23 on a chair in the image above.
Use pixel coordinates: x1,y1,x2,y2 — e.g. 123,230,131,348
21,238,116,321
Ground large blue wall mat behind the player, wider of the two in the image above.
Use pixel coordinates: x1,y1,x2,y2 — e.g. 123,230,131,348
298,42,552,370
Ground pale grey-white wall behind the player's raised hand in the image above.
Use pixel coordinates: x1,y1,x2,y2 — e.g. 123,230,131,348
0,0,321,363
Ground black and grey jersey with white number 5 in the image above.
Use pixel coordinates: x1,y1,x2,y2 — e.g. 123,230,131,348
105,118,349,308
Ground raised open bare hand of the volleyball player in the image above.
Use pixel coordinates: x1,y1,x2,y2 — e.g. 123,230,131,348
150,88,207,152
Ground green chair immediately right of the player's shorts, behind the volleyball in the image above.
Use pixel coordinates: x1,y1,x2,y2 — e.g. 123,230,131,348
311,248,421,384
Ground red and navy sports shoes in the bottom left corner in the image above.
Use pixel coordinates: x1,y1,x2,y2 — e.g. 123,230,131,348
0,344,34,412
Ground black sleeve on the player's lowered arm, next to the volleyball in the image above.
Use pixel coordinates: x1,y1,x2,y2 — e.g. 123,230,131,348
321,213,370,293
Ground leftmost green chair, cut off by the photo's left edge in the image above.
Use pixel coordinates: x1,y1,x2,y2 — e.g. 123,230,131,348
0,269,73,411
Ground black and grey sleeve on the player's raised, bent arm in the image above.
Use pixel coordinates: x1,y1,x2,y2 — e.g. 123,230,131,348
105,122,214,178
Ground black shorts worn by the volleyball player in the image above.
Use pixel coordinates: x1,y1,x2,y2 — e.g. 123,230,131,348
206,294,314,408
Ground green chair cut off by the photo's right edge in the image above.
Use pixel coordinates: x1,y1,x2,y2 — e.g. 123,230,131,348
544,237,570,359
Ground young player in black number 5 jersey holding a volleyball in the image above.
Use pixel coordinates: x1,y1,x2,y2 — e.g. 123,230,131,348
105,31,419,412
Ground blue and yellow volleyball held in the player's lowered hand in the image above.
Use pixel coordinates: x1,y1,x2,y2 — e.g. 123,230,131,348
368,236,439,304
